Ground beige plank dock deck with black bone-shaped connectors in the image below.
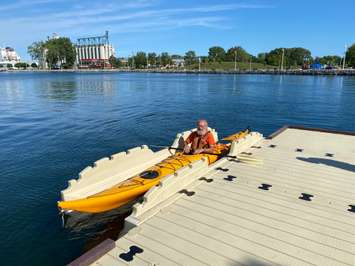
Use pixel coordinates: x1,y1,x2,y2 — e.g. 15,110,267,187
88,128,355,266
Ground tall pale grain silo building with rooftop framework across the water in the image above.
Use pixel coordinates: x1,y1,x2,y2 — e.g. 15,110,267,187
75,31,115,68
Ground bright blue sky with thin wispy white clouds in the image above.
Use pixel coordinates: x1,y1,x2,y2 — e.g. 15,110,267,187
0,0,355,59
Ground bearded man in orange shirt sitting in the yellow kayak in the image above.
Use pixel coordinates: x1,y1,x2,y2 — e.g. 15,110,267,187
184,119,216,154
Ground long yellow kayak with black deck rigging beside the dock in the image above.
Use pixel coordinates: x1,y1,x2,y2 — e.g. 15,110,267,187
58,130,249,213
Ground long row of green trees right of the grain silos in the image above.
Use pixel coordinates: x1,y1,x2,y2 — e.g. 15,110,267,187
110,44,355,68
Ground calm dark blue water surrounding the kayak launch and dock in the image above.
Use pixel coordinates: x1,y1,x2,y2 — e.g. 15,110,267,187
0,73,355,265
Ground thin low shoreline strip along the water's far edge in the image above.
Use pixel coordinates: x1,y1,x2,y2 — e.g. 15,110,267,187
0,69,355,76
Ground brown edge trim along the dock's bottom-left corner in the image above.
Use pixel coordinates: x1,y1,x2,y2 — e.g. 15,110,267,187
68,239,116,266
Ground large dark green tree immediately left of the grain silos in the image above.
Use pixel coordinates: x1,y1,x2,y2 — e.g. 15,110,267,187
45,37,76,68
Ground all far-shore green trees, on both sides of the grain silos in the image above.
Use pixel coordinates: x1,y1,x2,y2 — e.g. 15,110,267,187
28,37,355,69
